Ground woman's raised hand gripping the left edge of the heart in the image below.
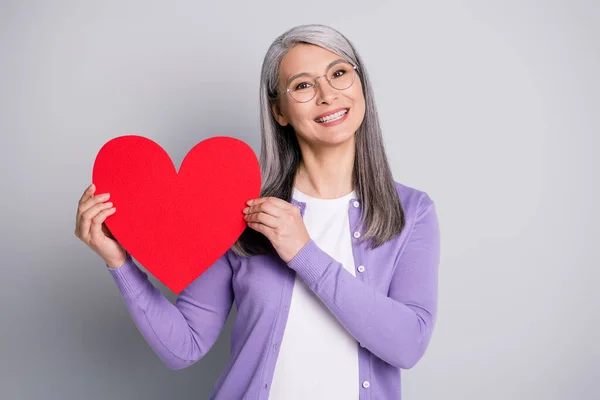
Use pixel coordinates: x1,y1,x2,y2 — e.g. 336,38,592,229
75,183,127,268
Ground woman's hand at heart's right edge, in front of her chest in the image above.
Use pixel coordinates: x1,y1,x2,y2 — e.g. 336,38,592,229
244,197,310,263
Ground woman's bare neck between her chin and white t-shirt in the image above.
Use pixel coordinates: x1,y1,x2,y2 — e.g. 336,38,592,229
294,137,355,199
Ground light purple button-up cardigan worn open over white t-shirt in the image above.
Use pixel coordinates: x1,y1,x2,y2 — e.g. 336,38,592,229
107,182,440,400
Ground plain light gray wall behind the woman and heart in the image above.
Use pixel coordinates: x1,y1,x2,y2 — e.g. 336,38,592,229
0,0,600,400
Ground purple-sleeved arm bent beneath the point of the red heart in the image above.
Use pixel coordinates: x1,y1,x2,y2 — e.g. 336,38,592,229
107,254,233,370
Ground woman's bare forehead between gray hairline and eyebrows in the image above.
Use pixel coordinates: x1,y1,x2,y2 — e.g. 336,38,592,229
279,44,343,81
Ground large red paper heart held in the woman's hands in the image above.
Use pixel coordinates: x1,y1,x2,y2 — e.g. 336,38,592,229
92,135,261,294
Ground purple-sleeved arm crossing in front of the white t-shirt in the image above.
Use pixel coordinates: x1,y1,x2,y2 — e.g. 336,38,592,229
288,195,440,369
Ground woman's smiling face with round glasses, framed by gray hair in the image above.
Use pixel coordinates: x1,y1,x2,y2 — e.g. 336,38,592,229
272,44,365,146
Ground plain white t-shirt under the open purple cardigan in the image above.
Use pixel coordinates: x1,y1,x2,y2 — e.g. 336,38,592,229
269,188,359,400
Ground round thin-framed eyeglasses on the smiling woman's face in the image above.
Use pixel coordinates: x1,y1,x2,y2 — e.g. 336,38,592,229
275,60,356,103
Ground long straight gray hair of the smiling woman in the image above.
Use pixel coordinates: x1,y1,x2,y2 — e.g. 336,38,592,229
231,25,405,257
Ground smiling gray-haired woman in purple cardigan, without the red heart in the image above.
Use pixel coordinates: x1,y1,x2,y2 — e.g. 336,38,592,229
76,25,439,400
